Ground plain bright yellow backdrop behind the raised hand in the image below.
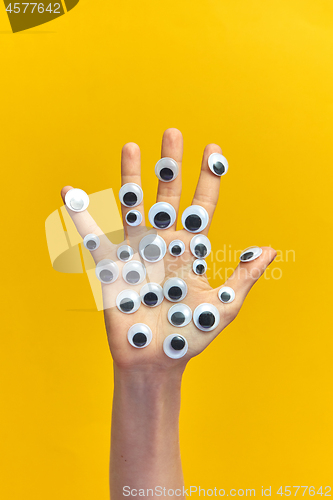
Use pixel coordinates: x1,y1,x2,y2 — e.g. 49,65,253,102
0,0,333,500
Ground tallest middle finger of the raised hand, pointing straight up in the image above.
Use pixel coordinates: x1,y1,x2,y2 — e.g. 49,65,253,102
156,128,183,230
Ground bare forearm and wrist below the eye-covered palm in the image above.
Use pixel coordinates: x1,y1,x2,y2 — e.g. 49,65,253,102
110,368,184,500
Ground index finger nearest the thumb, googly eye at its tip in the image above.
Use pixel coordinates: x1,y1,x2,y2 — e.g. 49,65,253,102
192,144,222,234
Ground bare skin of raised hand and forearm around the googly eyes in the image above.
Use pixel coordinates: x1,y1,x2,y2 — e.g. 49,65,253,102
61,128,276,500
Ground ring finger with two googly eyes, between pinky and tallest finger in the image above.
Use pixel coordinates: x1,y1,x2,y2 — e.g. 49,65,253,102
121,142,145,236
